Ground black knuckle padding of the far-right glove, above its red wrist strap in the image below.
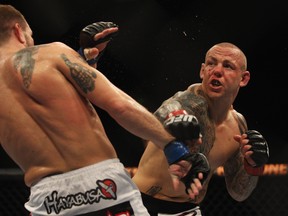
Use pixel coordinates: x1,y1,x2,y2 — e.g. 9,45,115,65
246,130,269,167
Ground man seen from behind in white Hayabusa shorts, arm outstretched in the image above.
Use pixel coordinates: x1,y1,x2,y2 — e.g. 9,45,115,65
0,4,202,216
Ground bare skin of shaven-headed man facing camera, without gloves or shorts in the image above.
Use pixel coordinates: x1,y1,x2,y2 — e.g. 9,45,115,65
133,43,258,204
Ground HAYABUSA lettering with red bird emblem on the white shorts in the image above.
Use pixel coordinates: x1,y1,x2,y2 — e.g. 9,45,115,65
44,179,117,214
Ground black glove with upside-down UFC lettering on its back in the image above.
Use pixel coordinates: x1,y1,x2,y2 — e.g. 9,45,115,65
164,110,200,141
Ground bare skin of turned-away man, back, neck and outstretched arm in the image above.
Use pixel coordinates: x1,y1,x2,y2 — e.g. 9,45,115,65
0,20,178,186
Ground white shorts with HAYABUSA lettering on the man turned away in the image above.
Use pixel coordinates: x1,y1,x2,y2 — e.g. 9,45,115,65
25,159,149,216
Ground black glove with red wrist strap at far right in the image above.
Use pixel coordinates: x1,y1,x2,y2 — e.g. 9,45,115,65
244,130,269,176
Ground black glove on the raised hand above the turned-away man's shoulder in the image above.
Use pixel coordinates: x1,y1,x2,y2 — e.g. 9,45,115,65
78,22,118,65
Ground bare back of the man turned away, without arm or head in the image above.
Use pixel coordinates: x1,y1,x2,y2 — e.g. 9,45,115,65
0,44,117,186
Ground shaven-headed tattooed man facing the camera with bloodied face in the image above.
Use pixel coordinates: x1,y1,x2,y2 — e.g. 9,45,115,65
133,42,269,216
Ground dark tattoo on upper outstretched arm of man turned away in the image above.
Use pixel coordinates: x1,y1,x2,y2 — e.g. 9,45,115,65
61,54,97,93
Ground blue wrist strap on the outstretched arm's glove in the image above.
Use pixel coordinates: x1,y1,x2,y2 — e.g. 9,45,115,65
164,140,190,165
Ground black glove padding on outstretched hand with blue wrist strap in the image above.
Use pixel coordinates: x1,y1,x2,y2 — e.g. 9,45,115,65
181,153,210,193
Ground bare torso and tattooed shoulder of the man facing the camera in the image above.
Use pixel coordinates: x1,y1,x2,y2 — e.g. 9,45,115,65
133,84,240,203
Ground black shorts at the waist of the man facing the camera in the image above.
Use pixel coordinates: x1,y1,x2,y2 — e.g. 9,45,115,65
141,193,202,216
